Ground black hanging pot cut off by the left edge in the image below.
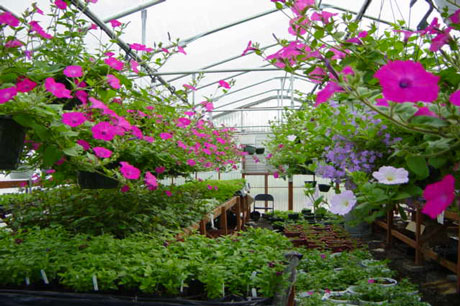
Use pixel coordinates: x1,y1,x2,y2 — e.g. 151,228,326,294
0,116,26,170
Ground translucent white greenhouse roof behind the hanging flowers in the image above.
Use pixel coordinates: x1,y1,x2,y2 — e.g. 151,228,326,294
3,0,439,130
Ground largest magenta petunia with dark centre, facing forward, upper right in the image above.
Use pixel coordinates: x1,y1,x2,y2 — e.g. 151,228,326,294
374,60,439,103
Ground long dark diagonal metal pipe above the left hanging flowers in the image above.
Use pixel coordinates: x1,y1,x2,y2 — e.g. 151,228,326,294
70,0,189,104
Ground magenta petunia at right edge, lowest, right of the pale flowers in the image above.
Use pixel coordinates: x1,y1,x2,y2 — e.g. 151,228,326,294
422,174,455,219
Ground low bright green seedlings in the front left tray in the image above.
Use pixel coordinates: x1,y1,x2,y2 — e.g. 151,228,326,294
0,227,291,298
